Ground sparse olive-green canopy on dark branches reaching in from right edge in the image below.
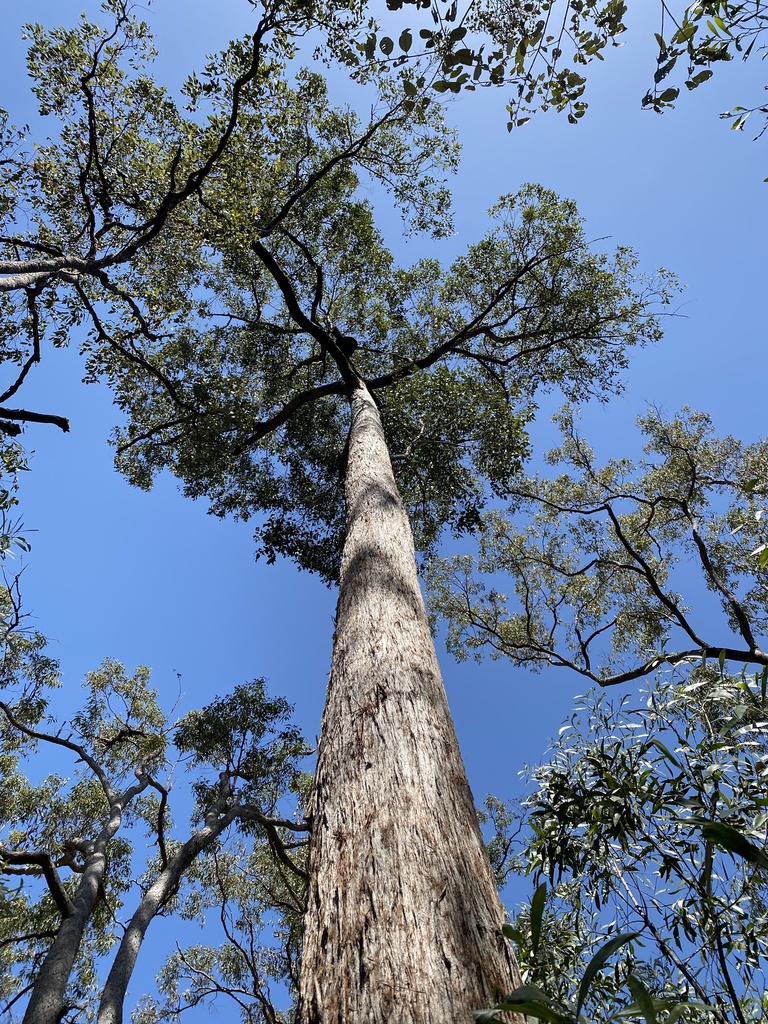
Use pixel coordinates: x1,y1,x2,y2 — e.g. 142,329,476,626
431,410,768,686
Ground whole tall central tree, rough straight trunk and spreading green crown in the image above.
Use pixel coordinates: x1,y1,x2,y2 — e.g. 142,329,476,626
94,75,671,1024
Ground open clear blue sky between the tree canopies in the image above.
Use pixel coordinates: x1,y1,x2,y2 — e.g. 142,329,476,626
0,0,768,1007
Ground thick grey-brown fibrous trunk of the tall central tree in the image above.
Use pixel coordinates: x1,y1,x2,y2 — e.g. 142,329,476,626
299,386,520,1024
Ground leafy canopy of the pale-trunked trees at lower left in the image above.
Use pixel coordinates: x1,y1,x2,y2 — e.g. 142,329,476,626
0,636,307,1021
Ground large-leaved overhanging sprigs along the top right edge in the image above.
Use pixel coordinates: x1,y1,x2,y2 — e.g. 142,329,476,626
358,0,768,143
